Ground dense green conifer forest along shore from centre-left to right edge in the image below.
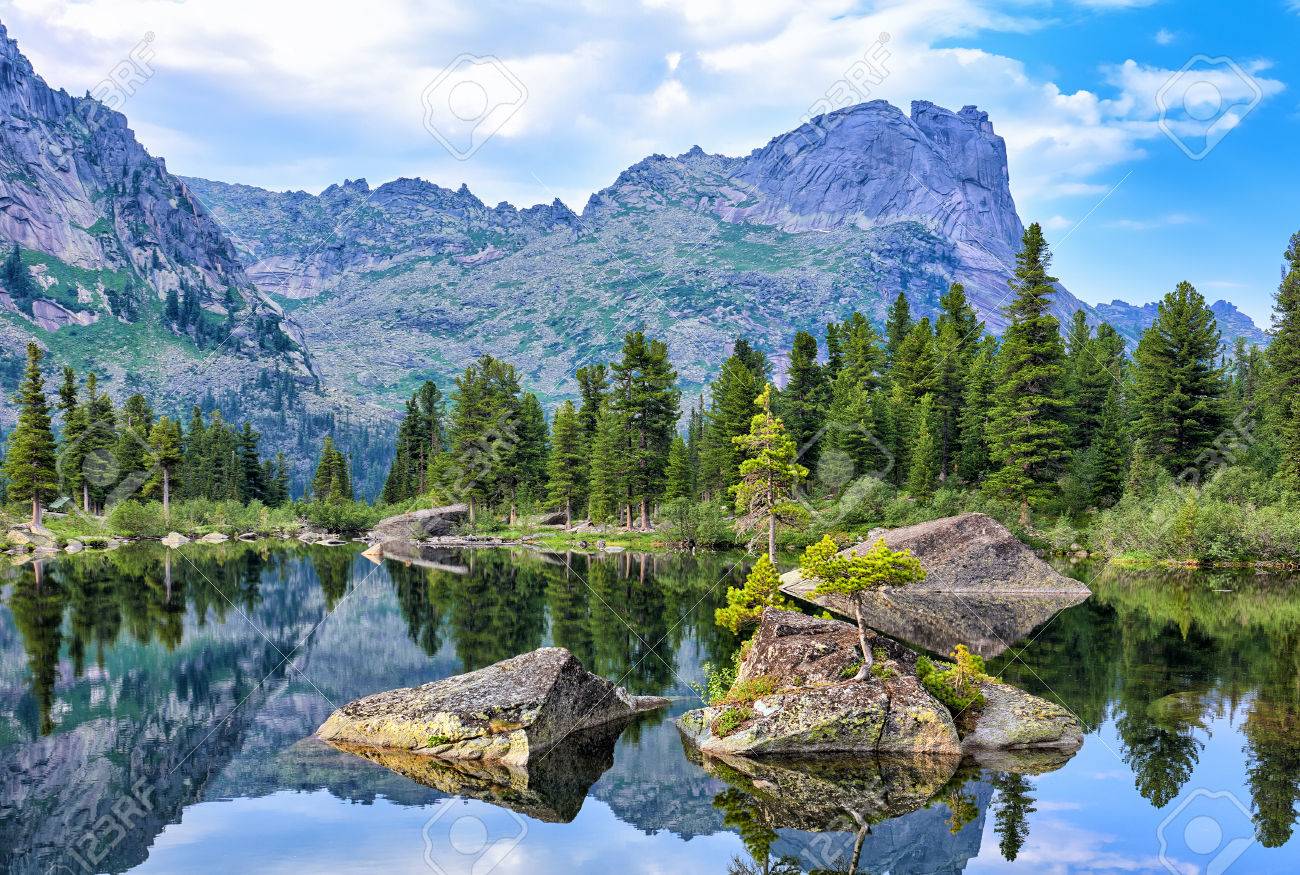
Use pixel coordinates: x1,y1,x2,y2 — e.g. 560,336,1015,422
371,224,1300,543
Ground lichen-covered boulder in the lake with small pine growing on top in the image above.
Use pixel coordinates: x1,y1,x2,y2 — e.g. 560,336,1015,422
677,608,961,755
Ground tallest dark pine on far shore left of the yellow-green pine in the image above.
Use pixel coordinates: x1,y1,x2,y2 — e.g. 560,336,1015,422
610,332,681,529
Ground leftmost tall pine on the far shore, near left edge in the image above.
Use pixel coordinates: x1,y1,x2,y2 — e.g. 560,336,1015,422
4,343,59,525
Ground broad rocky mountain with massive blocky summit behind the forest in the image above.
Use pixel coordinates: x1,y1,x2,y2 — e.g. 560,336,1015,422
186,100,1265,407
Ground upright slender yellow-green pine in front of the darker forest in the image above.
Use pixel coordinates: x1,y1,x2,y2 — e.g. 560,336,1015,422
732,384,809,563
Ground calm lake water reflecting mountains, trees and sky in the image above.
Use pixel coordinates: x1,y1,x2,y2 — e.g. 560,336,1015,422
0,545,1300,875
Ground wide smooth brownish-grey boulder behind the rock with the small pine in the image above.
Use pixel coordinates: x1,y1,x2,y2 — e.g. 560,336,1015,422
781,514,1089,600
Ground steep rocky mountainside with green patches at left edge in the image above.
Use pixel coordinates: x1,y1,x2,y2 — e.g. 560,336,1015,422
0,25,390,483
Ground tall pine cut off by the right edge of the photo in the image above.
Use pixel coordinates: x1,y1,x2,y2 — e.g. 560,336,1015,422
1268,233,1300,493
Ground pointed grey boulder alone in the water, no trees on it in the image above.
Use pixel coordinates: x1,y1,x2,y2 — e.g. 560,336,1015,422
316,647,668,766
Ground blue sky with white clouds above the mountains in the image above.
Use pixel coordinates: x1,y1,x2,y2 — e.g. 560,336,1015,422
0,0,1300,325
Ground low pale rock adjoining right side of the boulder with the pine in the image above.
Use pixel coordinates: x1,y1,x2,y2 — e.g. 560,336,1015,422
962,681,1083,751
